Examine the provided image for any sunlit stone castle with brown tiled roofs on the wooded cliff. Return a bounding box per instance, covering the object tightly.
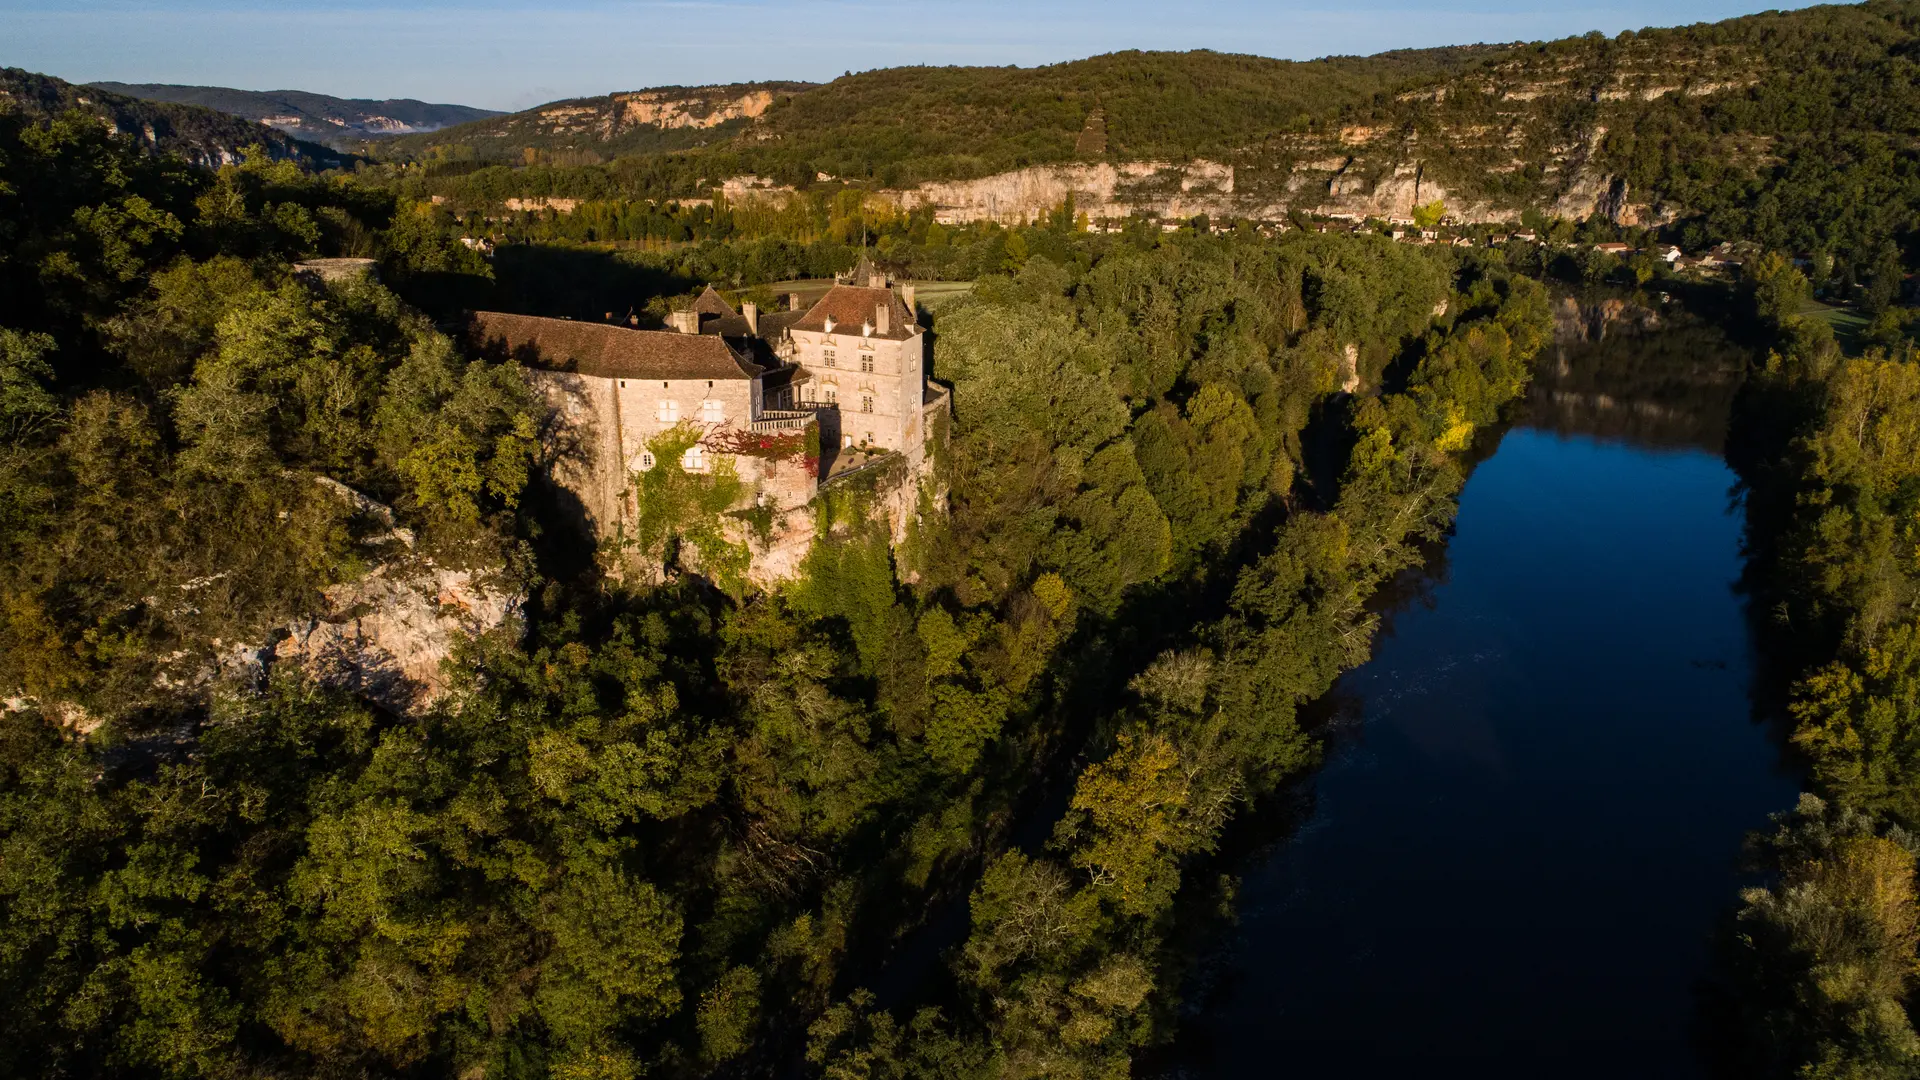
[468,259,948,568]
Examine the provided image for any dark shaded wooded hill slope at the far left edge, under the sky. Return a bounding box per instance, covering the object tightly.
[0,67,353,169]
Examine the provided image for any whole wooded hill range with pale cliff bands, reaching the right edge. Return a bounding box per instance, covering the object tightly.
[376,0,1920,247]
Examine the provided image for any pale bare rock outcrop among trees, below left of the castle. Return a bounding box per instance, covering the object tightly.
[263,567,522,713]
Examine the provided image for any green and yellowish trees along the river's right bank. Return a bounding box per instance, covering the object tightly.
[1715,256,1920,1078]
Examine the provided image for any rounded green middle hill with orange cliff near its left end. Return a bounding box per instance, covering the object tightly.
[380,46,1482,184]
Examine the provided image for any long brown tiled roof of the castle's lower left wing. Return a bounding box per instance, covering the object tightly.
[467,311,760,379]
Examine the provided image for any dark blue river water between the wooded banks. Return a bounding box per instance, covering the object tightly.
[1173,305,1799,1078]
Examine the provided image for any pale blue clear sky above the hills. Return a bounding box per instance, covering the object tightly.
[0,0,1801,110]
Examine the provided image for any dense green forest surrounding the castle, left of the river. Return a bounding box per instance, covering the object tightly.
[0,88,1549,1078]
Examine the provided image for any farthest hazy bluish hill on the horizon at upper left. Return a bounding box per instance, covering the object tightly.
[88,83,503,142]
